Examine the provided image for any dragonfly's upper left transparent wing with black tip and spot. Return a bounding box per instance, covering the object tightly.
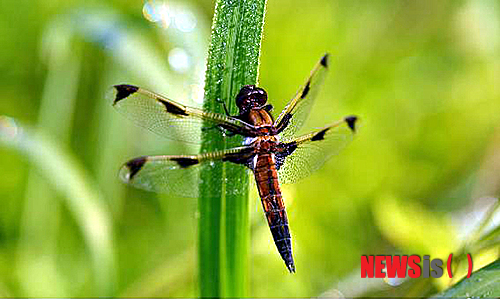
[111,84,254,144]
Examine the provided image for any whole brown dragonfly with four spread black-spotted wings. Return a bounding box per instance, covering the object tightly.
[112,54,358,273]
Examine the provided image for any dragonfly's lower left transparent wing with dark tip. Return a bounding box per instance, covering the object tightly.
[119,146,253,197]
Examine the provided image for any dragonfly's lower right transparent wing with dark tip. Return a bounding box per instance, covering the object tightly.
[275,116,357,184]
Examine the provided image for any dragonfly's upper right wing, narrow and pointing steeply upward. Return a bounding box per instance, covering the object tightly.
[274,54,328,141]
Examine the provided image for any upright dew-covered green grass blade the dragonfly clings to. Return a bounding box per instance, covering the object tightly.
[199,0,266,297]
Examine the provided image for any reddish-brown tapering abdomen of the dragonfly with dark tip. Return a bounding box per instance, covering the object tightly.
[254,154,295,272]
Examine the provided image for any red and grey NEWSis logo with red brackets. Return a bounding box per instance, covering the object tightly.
[361,254,472,278]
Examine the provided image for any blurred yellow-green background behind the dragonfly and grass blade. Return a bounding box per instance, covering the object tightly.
[0,0,500,297]
